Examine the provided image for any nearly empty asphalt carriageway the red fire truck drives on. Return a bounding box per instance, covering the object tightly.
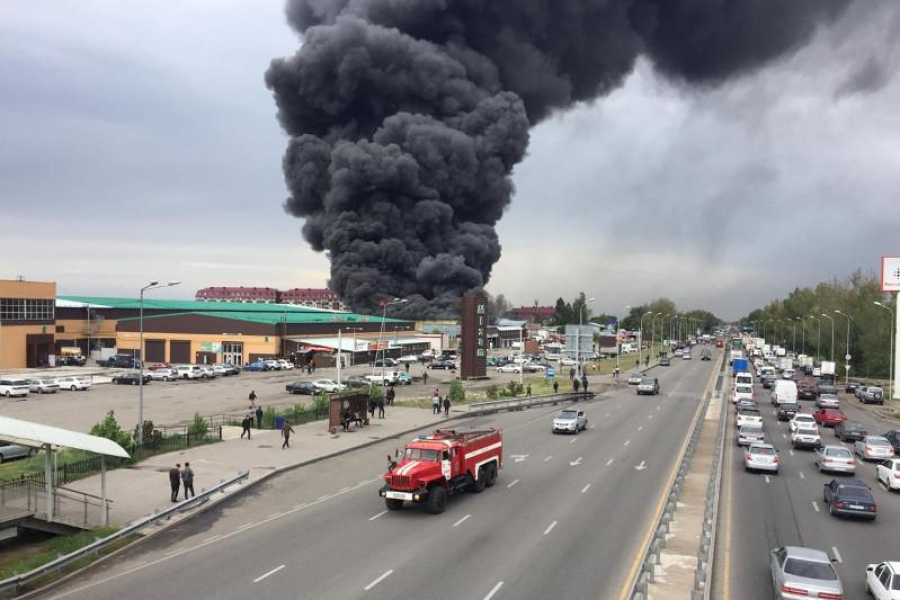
[44,352,715,600]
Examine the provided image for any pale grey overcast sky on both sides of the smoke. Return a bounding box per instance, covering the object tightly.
[0,0,900,319]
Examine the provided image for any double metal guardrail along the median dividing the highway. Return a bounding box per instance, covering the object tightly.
[625,354,728,600]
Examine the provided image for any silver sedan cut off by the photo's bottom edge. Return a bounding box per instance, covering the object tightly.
[771,546,844,600]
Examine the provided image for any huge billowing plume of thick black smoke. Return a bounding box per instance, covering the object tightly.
[266,0,849,317]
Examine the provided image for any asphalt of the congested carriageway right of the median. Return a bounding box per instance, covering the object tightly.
[713,372,900,600]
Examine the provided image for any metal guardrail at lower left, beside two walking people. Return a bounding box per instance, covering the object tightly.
[0,471,250,593]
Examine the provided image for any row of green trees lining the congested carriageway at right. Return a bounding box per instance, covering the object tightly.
[741,270,896,378]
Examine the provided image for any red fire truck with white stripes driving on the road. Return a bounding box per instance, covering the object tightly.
[380,428,503,515]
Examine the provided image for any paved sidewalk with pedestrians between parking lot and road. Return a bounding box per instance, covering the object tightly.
[67,406,445,526]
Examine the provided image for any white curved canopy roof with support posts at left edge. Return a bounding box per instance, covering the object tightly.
[0,417,129,525]
